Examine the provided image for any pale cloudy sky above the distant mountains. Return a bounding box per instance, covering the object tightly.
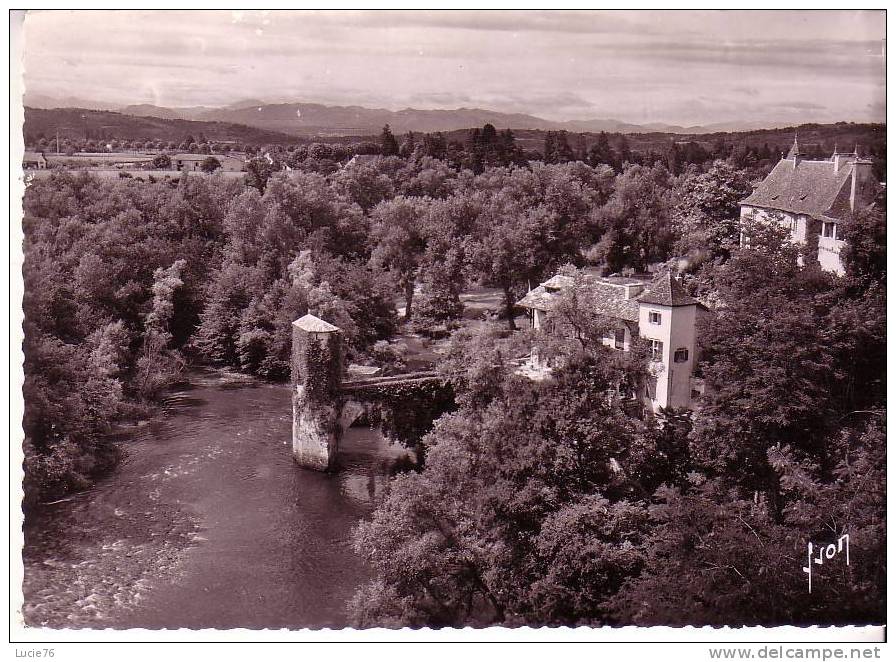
[23,10,886,126]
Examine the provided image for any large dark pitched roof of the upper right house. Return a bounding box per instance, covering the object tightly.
[740,159,855,219]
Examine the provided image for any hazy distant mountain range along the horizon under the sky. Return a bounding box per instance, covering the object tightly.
[19,93,792,138]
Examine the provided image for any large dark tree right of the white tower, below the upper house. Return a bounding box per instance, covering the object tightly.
[691,222,885,517]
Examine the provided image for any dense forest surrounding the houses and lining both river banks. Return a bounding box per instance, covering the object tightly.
[17,125,886,627]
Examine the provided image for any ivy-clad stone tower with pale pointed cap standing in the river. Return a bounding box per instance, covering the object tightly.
[292,315,342,471]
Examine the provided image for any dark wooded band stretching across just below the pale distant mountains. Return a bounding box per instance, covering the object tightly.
[26,116,886,181]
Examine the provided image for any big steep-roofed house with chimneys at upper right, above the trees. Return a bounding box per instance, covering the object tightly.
[740,137,874,275]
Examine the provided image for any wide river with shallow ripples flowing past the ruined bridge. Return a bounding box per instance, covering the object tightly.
[23,371,406,629]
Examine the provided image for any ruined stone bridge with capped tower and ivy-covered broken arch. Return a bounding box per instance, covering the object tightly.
[292,315,453,471]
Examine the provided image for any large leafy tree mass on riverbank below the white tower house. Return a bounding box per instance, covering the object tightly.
[351,350,647,627]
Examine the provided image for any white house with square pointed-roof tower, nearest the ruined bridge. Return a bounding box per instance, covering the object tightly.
[517,270,705,412]
